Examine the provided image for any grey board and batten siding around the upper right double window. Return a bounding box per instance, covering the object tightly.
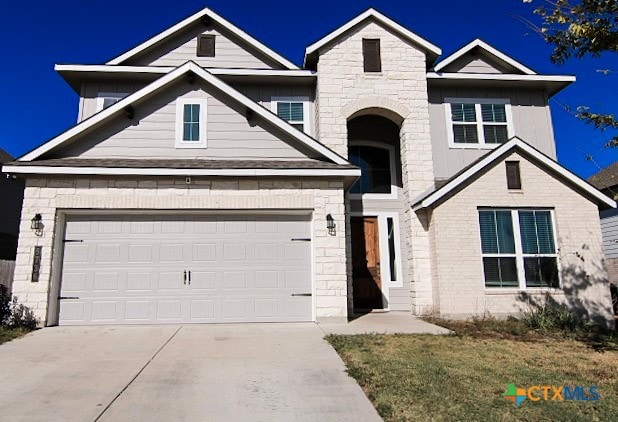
[429,86,556,180]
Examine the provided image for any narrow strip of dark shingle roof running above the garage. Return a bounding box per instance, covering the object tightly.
[7,158,356,170]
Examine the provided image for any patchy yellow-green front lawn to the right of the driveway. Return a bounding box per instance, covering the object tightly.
[327,320,618,421]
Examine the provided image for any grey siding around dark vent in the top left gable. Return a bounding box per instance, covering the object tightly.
[123,23,281,69]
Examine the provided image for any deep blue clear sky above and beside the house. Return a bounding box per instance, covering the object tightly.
[0,0,618,177]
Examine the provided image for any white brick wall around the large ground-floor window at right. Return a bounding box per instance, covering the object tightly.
[431,153,610,326]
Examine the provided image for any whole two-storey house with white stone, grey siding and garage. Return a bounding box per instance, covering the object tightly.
[5,9,616,325]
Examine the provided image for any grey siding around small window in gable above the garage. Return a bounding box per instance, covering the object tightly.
[54,82,315,160]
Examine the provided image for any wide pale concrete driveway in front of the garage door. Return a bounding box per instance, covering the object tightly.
[0,323,380,422]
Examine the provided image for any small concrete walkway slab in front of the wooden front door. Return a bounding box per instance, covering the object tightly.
[319,312,451,334]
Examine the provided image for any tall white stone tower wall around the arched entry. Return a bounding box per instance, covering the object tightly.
[316,22,434,314]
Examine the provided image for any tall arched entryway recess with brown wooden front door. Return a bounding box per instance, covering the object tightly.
[347,112,403,312]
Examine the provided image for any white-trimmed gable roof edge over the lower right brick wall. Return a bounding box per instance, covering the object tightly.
[412,137,616,211]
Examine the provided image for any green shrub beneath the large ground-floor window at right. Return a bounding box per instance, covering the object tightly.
[521,301,584,332]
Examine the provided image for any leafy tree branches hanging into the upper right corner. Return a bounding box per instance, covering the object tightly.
[523,0,618,147]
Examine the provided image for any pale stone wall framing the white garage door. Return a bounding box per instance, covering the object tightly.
[13,178,347,325]
